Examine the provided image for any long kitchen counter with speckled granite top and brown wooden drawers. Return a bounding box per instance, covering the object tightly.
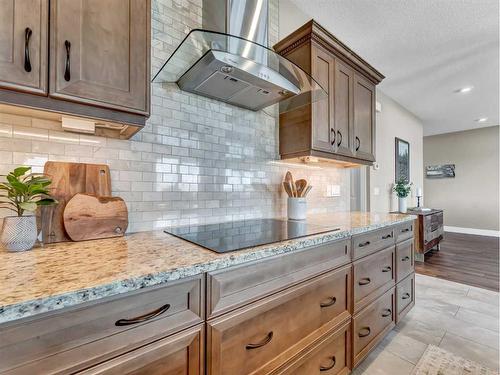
[0,213,415,374]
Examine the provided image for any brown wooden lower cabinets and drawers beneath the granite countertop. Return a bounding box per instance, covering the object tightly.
[0,222,415,375]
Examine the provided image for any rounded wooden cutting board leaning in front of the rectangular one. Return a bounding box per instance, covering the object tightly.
[63,193,128,241]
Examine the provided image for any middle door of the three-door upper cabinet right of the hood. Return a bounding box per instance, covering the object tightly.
[334,59,354,156]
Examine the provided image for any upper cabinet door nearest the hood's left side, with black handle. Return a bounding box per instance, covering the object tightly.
[50,0,151,114]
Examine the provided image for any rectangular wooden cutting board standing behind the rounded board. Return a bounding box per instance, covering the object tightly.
[41,161,111,243]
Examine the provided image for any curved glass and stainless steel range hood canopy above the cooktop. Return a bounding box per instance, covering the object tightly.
[152,29,328,113]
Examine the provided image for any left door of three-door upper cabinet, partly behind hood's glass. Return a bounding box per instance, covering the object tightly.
[311,44,335,153]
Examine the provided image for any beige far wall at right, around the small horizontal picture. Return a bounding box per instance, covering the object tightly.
[424,126,499,230]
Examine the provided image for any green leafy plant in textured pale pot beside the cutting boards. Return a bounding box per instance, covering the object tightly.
[0,167,57,251]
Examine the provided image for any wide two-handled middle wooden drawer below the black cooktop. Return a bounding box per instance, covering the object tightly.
[207,266,351,375]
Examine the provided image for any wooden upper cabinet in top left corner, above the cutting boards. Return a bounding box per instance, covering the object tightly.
[0,0,151,138]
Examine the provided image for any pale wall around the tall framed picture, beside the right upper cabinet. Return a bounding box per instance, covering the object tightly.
[370,90,423,212]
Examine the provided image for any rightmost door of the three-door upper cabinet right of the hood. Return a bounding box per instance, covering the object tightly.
[353,74,375,161]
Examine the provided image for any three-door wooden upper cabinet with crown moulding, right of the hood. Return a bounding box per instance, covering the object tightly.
[274,21,384,164]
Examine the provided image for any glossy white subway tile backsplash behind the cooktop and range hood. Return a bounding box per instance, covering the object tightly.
[0,0,349,232]
